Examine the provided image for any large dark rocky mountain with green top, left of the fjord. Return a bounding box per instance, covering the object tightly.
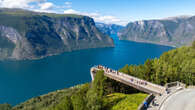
[0,9,114,60]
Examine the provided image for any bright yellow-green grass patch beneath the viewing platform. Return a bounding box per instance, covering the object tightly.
[103,93,147,110]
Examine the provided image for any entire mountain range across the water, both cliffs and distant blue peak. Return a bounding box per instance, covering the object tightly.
[0,8,195,60]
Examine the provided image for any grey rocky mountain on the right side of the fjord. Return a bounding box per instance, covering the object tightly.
[118,16,195,47]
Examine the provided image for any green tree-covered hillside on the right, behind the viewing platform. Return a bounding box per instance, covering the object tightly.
[120,42,195,85]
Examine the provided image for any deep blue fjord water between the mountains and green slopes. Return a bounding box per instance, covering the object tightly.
[0,35,172,105]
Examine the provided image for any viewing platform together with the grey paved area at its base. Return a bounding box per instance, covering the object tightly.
[90,65,195,110]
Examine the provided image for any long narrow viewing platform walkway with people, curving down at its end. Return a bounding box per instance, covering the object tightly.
[90,65,166,95]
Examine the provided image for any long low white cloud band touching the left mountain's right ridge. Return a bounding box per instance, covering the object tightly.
[64,9,128,25]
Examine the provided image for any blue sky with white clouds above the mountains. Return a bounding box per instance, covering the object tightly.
[0,0,195,25]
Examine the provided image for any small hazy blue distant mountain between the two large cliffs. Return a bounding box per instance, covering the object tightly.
[96,22,124,35]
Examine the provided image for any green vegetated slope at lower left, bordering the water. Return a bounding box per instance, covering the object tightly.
[11,85,83,110]
